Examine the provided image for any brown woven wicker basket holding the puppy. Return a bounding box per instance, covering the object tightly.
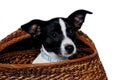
[0,29,107,80]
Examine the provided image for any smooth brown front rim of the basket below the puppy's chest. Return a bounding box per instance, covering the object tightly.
[0,52,97,68]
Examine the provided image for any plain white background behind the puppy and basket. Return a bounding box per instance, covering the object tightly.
[0,0,120,80]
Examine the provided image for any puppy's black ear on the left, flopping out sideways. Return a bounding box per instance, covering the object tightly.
[21,20,45,37]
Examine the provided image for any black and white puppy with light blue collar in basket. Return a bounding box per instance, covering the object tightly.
[21,10,92,63]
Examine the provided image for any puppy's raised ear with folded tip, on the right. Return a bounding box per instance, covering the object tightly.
[68,10,92,29]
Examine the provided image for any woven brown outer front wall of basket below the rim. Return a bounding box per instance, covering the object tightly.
[0,56,106,80]
